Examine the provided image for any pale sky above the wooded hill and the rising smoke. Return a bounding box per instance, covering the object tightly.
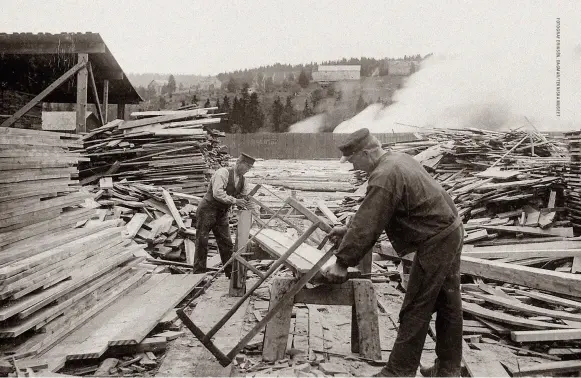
[0,0,581,75]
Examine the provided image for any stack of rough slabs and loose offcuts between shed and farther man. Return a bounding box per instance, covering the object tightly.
[73,108,235,262]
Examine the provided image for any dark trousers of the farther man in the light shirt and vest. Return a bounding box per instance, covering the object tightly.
[194,199,233,278]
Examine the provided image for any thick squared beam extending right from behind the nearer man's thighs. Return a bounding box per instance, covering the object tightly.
[460,256,581,298]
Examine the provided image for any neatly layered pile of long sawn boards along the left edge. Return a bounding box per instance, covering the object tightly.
[0,128,200,371]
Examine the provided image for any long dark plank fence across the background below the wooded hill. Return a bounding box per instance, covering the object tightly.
[221,133,416,160]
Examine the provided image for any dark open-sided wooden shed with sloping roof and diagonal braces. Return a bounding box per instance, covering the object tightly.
[0,33,142,133]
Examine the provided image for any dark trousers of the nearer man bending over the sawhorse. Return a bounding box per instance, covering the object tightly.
[381,226,464,377]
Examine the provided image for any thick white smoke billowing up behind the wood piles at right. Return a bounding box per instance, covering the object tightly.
[334,20,581,133]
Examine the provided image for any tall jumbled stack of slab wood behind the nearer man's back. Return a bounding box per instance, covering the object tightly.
[336,129,573,243]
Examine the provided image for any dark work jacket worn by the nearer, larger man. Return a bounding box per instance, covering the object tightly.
[336,152,462,266]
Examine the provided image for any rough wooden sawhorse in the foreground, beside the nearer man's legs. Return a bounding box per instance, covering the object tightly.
[262,277,381,361]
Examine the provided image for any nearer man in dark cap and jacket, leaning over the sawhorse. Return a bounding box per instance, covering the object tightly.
[322,129,464,377]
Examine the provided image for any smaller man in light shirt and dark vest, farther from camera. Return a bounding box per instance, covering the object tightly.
[194,154,256,278]
